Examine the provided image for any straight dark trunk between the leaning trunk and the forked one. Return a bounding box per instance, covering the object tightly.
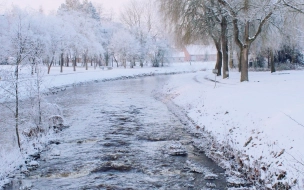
[221,17,229,79]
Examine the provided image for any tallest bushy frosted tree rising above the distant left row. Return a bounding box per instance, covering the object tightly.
[58,1,104,70]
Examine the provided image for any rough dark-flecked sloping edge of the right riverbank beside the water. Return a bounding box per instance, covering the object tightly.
[154,91,296,190]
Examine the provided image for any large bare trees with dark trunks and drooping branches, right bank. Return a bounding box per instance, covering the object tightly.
[159,0,303,82]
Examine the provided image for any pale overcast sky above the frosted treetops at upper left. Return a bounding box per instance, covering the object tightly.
[0,0,129,14]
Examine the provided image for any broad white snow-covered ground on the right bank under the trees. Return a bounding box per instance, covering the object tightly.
[163,71,304,189]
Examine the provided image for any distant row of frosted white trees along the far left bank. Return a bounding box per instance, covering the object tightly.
[0,0,169,73]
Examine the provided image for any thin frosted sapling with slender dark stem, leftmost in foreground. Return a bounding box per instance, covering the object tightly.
[0,7,39,149]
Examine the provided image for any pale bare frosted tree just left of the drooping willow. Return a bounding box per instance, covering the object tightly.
[120,0,171,67]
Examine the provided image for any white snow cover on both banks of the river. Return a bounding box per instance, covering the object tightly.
[0,63,304,189]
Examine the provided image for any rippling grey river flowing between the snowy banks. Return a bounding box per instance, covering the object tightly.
[6,76,226,190]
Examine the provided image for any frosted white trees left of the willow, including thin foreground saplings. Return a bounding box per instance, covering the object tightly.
[0,0,170,149]
